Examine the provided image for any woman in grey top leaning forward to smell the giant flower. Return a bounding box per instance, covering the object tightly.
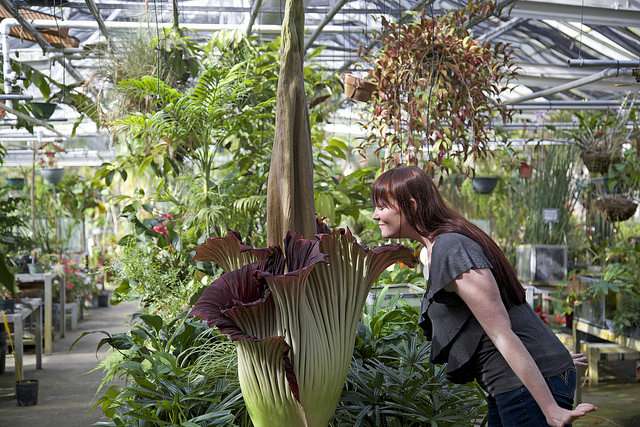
[372,167,596,427]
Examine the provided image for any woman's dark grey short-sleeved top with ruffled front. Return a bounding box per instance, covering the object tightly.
[420,233,573,395]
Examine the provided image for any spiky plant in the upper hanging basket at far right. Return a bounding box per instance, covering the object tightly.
[564,102,635,175]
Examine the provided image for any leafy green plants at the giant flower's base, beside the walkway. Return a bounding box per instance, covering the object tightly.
[79,313,248,427]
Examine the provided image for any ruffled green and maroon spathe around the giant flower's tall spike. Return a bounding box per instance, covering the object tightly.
[192,230,414,427]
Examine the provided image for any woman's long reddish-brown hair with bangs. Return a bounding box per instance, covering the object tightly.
[371,167,525,308]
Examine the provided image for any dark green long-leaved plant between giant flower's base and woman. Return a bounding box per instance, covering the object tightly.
[333,335,486,427]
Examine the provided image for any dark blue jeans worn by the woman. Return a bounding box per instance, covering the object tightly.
[487,368,576,427]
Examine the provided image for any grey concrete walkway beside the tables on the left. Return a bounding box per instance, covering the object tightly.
[0,303,138,427]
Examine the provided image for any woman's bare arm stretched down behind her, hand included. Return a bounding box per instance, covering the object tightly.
[448,269,596,427]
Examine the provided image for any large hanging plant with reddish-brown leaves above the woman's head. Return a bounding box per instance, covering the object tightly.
[361,1,515,171]
